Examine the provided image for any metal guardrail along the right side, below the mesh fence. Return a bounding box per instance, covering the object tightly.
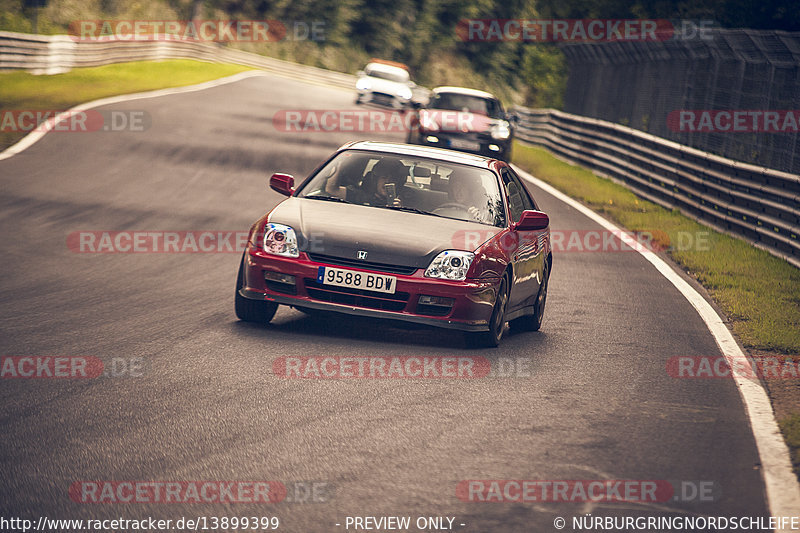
[516,108,800,268]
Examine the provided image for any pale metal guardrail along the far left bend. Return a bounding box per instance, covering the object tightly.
[0,31,356,89]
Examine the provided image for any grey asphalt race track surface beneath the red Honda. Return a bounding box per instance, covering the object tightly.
[0,71,767,532]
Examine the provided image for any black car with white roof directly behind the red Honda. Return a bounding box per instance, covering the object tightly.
[407,87,517,161]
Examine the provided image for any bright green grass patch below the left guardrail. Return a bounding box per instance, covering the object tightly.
[0,59,251,150]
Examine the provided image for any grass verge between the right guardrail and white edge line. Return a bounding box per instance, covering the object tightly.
[514,143,800,354]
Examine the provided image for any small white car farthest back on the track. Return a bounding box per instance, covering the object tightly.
[356,59,416,109]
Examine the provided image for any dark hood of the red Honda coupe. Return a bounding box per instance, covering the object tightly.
[269,197,501,268]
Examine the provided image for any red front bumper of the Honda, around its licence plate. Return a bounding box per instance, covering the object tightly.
[239,245,500,331]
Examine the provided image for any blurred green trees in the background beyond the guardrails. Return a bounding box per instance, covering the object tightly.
[0,0,800,108]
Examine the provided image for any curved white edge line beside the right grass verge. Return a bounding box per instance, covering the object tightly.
[514,165,800,532]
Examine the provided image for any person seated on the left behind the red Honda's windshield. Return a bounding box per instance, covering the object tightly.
[325,158,408,207]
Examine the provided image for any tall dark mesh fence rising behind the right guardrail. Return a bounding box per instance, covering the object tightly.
[559,28,800,174]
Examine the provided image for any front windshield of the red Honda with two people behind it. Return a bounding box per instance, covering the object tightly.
[297,150,505,227]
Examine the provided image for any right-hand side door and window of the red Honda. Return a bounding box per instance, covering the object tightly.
[500,167,545,310]
